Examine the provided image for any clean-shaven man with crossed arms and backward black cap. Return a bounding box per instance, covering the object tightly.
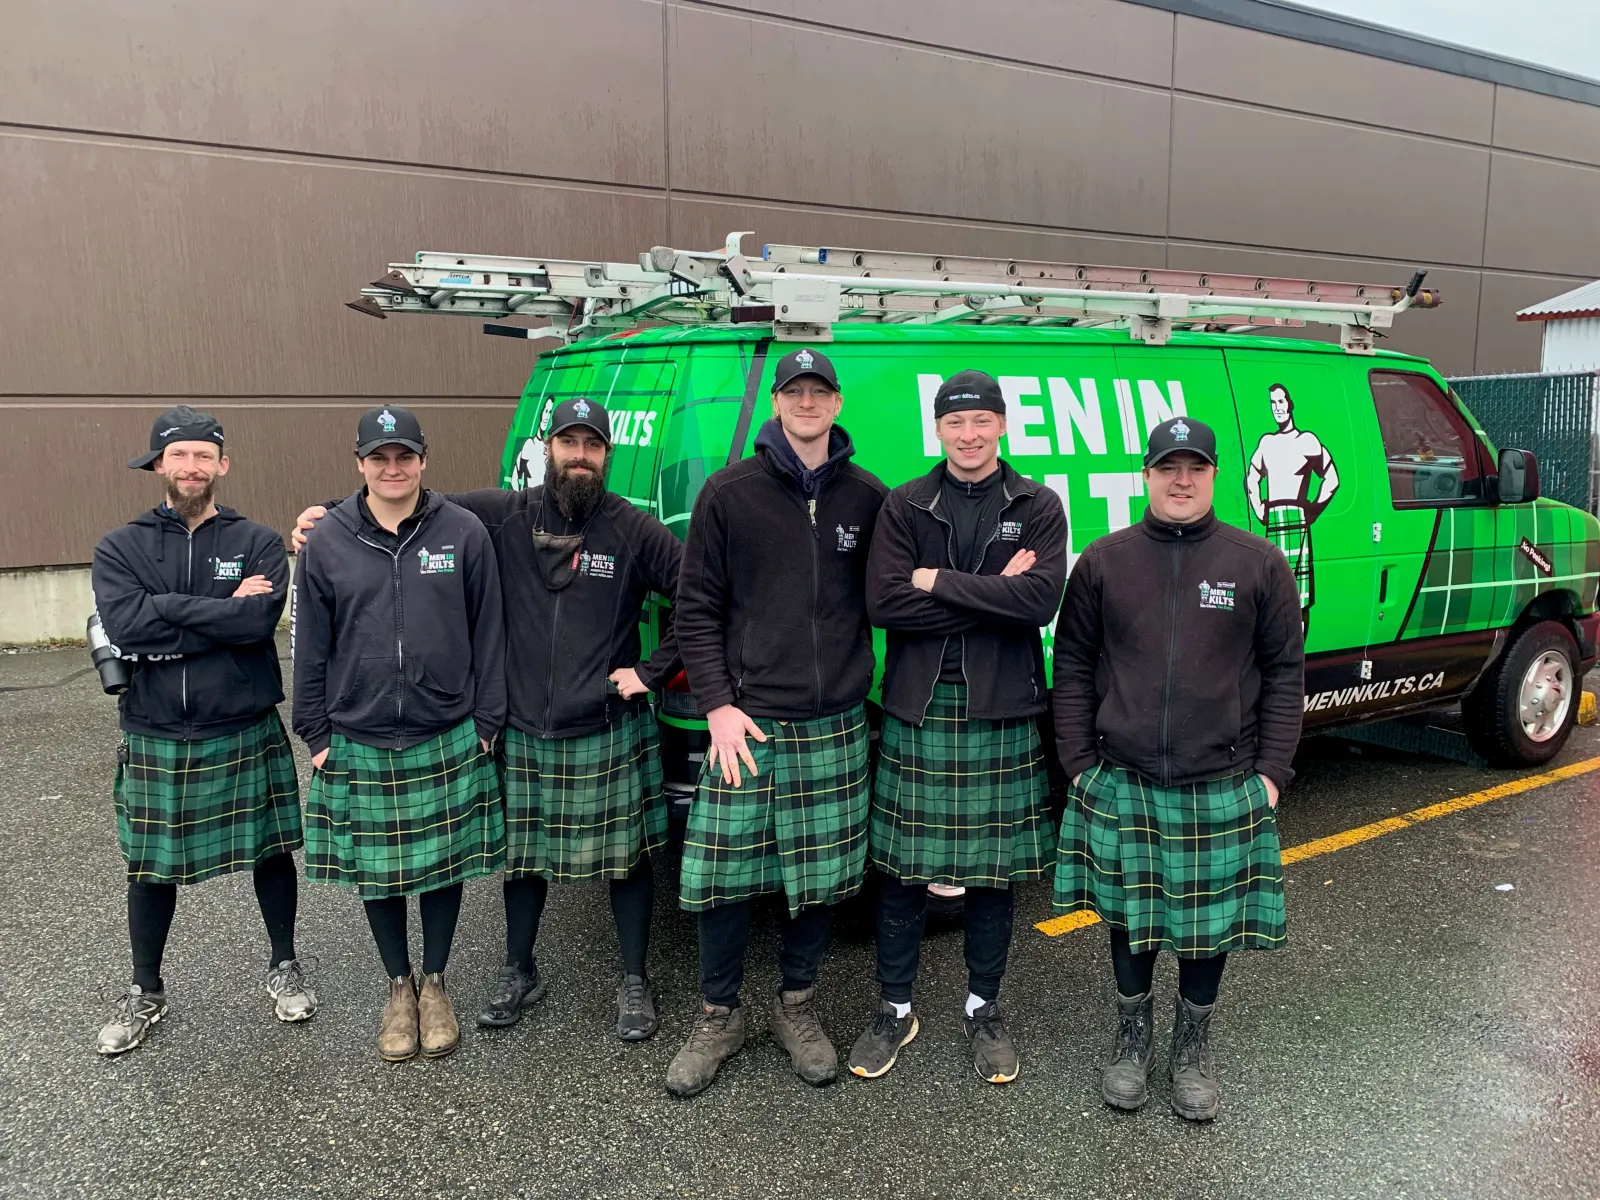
[850,371,1067,1083]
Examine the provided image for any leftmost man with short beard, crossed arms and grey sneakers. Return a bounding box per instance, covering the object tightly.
[93,405,317,1054]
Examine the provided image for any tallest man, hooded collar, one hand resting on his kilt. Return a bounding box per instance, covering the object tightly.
[667,349,888,1096]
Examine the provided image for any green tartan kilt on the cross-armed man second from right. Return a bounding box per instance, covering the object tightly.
[869,683,1056,888]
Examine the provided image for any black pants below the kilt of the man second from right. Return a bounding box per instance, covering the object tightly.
[878,874,1016,1005]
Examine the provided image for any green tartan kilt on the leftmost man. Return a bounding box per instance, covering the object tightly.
[112,709,301,883]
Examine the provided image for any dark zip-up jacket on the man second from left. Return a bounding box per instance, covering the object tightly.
[291,488,506,754]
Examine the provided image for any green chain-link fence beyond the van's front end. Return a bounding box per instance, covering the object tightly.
[1450,371,1600,512]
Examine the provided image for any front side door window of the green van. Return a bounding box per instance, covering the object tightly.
[1371,371,1483,509]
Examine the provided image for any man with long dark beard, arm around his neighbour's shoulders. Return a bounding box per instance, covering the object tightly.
[296,398,683,1042]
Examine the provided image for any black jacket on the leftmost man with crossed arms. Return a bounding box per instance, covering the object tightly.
[90,504,290,741]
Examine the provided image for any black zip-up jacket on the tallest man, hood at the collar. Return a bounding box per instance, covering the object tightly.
[675,421,888,720]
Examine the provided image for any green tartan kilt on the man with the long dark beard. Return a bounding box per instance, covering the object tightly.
[501,706,667,883]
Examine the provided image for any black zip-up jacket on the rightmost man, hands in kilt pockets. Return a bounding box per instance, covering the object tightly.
[1054,510,1306,789]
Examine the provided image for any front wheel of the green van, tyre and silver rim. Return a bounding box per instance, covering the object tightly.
[1461,621,1579,766]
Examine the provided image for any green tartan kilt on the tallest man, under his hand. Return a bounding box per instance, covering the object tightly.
[678,704,869,914]
